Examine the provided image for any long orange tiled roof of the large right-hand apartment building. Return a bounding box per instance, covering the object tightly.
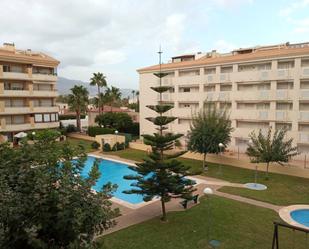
[137,47,309,73]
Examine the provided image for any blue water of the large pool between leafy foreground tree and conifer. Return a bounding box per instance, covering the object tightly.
[82,156,143,204]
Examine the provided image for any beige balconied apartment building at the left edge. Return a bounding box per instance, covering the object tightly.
[0,43,59,141]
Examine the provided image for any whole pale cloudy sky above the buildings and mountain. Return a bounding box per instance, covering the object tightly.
[0,0,309,89]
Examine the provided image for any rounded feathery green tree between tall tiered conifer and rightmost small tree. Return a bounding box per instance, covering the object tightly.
[188,103,233,170]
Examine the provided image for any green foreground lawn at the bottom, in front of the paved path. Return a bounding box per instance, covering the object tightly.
[99,196,309,249]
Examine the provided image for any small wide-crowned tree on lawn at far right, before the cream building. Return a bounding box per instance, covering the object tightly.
[246,127,298,178]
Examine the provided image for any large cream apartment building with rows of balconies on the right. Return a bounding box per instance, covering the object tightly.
[138,43,309,153]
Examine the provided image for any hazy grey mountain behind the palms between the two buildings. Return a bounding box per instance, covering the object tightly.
[57,77,136,98]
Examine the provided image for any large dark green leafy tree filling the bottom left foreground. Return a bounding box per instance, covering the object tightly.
[0,131,118,249]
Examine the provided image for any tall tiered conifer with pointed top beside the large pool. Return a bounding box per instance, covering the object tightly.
[125,52,194,221]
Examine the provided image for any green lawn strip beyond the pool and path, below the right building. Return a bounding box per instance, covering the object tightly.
[102,149,309,205]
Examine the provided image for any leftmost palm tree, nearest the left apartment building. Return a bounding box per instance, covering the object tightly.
[68,85,89,131]
